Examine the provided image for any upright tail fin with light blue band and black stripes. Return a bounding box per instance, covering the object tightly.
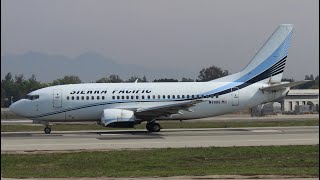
[238,24,294,83]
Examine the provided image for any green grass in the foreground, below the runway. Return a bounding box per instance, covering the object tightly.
[1,145,319,178]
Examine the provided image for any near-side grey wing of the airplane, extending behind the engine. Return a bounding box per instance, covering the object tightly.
[135,99,203,119]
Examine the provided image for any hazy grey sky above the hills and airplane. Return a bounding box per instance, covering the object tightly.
[1,0,319,79]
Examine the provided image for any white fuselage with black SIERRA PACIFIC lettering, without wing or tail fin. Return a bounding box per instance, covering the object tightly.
[9,82,286,121]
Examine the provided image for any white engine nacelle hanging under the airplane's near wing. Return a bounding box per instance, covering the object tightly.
[101,109,136,128]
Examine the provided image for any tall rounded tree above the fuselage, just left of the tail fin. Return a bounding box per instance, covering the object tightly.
[197,65,229,82]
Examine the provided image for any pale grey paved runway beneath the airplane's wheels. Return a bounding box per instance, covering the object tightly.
[1,126,319,153]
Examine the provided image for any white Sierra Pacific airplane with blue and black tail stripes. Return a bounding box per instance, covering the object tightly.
[9,24,304,134]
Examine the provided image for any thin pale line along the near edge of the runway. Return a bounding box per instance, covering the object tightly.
[2,138,318,147]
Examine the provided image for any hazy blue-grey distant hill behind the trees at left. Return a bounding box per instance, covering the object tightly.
[1,51,200,82]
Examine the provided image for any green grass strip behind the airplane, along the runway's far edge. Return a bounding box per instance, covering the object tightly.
[1,119,319,132]
